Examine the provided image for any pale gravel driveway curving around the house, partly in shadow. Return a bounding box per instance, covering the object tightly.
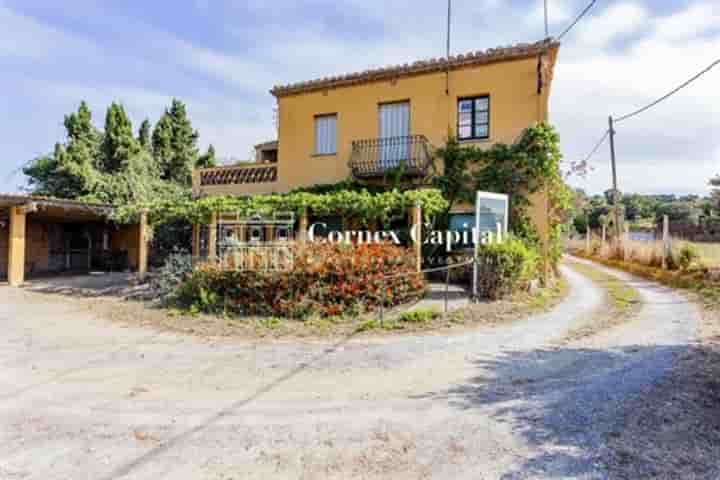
[0,260,699,480]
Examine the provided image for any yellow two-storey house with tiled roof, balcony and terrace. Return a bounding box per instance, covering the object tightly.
[193,40,560,244]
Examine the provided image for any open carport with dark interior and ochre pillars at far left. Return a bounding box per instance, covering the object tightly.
[0,194,148,286]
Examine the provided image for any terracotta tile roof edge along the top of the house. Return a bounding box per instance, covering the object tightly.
[270,39,560,97]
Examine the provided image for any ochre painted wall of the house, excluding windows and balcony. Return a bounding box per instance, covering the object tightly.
[195,50,557,248]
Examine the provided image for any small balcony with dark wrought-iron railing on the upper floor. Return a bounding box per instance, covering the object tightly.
[349,135,432,178]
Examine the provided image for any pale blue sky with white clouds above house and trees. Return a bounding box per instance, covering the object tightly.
[0,0,720,194]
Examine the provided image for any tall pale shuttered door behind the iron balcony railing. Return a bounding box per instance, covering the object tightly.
[378,102,410,170]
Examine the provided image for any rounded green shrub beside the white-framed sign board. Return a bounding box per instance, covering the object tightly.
[478,238,540,300]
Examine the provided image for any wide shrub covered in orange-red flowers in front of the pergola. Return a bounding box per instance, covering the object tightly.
[179,243,426,318]
